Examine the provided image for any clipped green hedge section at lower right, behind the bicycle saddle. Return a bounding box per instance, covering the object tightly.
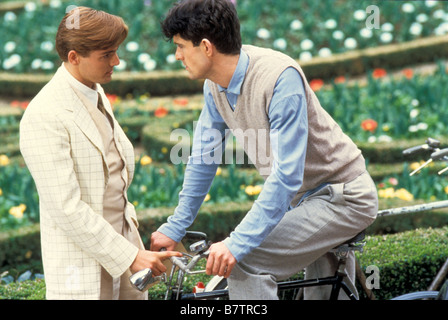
[358,226,448,300]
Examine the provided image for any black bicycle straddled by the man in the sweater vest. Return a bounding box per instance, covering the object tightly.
[129,231,365,300]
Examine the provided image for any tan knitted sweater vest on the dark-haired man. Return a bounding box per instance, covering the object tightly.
[207,45,366,203]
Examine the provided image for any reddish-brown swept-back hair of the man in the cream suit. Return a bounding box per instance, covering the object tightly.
[56,7,129,62]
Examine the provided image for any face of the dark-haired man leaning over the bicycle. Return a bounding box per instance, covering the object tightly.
[173,35,211,79]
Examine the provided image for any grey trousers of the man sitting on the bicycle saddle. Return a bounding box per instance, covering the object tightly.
[228,172,378,300]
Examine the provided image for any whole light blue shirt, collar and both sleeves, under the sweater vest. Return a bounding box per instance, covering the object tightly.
[159,51,308,261]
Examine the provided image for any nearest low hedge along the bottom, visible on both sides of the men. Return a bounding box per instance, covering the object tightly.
[0,227,448,300]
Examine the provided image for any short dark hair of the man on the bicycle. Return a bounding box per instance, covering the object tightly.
[161,0,241,54]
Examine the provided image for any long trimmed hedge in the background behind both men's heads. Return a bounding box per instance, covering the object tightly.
[0,36,448,98]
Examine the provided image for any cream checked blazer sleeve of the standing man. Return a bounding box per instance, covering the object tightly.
[20,106,138,277]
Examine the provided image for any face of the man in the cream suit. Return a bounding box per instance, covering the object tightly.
[71,48,120,88]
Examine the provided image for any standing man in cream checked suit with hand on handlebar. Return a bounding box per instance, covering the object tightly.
[20,7,180,299]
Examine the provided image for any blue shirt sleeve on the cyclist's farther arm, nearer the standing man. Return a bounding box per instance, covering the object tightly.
[158,81,230,242]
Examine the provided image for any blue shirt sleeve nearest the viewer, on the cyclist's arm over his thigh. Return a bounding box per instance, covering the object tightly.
[224,68,308,261]
